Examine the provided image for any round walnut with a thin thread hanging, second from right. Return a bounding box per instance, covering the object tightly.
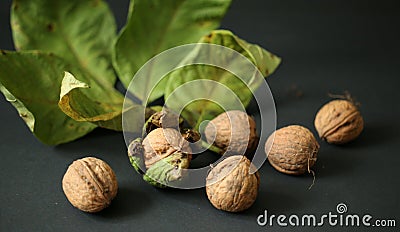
[265,125,319,175]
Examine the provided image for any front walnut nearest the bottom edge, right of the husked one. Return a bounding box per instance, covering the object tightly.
[206,155,260,212]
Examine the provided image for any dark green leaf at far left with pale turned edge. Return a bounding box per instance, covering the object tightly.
[0,51,96,145]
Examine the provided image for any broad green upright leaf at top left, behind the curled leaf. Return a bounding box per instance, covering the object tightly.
[11,0,116,87]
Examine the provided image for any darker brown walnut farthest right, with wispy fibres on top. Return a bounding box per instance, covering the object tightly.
[314,100,364,144]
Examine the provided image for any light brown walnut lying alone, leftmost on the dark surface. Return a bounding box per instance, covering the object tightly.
[62,157,118,213]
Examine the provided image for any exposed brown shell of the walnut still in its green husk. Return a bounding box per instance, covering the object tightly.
[142,128,192,168]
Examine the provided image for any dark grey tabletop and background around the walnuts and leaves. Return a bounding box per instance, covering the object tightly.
[0,0,400,231]
